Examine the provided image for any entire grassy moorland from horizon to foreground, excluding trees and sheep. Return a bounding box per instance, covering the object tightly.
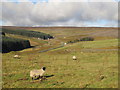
[2,27,118,88]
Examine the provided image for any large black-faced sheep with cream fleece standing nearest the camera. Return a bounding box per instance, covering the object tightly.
[30,67,46,80]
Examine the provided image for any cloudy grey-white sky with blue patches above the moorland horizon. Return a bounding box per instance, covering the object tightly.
[0,0,119,27]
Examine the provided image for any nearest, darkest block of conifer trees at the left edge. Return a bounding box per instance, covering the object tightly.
[0,36,31,53]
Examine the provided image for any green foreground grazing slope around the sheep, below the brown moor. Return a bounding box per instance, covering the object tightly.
[3,39,118,88]
